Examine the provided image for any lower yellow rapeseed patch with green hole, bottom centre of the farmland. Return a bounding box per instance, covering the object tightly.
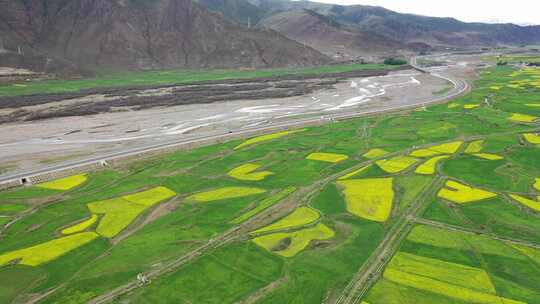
[253,224,335,258]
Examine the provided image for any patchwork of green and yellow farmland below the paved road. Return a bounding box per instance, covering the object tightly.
[0,61,540,304]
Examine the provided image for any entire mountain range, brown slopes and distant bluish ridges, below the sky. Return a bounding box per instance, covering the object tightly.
[0,0,540,72]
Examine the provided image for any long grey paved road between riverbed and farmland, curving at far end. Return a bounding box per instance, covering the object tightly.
[0,58,469,184]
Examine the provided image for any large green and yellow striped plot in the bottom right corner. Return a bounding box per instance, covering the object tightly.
[366,226,540,304]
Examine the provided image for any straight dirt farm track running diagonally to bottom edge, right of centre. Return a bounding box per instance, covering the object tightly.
[334,177,445,304]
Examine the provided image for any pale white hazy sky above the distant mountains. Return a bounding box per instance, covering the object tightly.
[313,0,540,24]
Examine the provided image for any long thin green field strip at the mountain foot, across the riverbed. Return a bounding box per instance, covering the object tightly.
[0,64,396,97]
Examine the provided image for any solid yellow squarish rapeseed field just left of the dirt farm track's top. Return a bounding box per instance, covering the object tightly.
[337,178,394,222]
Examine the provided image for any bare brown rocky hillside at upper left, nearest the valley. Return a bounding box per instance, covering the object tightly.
[0,0,329,70]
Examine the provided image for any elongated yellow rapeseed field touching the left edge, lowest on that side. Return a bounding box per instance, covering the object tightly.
[0,232,98,266]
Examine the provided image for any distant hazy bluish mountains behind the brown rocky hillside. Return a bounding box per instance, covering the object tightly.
[199,0,540,53]
